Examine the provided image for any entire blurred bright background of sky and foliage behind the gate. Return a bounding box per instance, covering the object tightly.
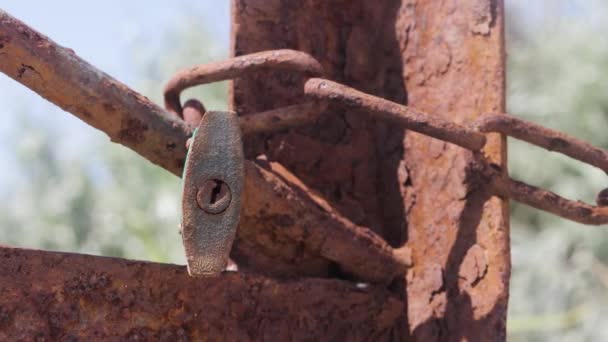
[0,0,608,341]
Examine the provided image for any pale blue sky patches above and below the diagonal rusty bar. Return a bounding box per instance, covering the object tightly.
[0,0,230,187]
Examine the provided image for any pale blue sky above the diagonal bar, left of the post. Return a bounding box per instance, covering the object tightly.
[0,0,230,83]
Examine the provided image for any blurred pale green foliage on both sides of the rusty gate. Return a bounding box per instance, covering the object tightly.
[0,0,608,341]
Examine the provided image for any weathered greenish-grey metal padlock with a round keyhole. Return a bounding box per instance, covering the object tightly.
[181,111,244,277]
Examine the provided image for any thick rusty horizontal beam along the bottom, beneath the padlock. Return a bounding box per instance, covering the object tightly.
[0,247,403,341]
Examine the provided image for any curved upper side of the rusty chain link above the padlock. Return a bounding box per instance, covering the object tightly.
[164,50,323,117]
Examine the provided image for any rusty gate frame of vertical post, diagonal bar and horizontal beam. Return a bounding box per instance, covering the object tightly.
[0,0,510,341]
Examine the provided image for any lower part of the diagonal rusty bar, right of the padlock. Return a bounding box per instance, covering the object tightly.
[238,160,411,283]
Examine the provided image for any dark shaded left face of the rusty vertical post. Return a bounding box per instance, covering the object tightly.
[232,0,406,256]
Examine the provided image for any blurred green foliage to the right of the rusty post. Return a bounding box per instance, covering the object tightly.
[507,0,608,341]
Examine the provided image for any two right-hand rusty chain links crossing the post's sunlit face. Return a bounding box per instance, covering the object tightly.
[304,78,608,225]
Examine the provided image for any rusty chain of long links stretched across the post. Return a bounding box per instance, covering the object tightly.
[165,50,608,225]
